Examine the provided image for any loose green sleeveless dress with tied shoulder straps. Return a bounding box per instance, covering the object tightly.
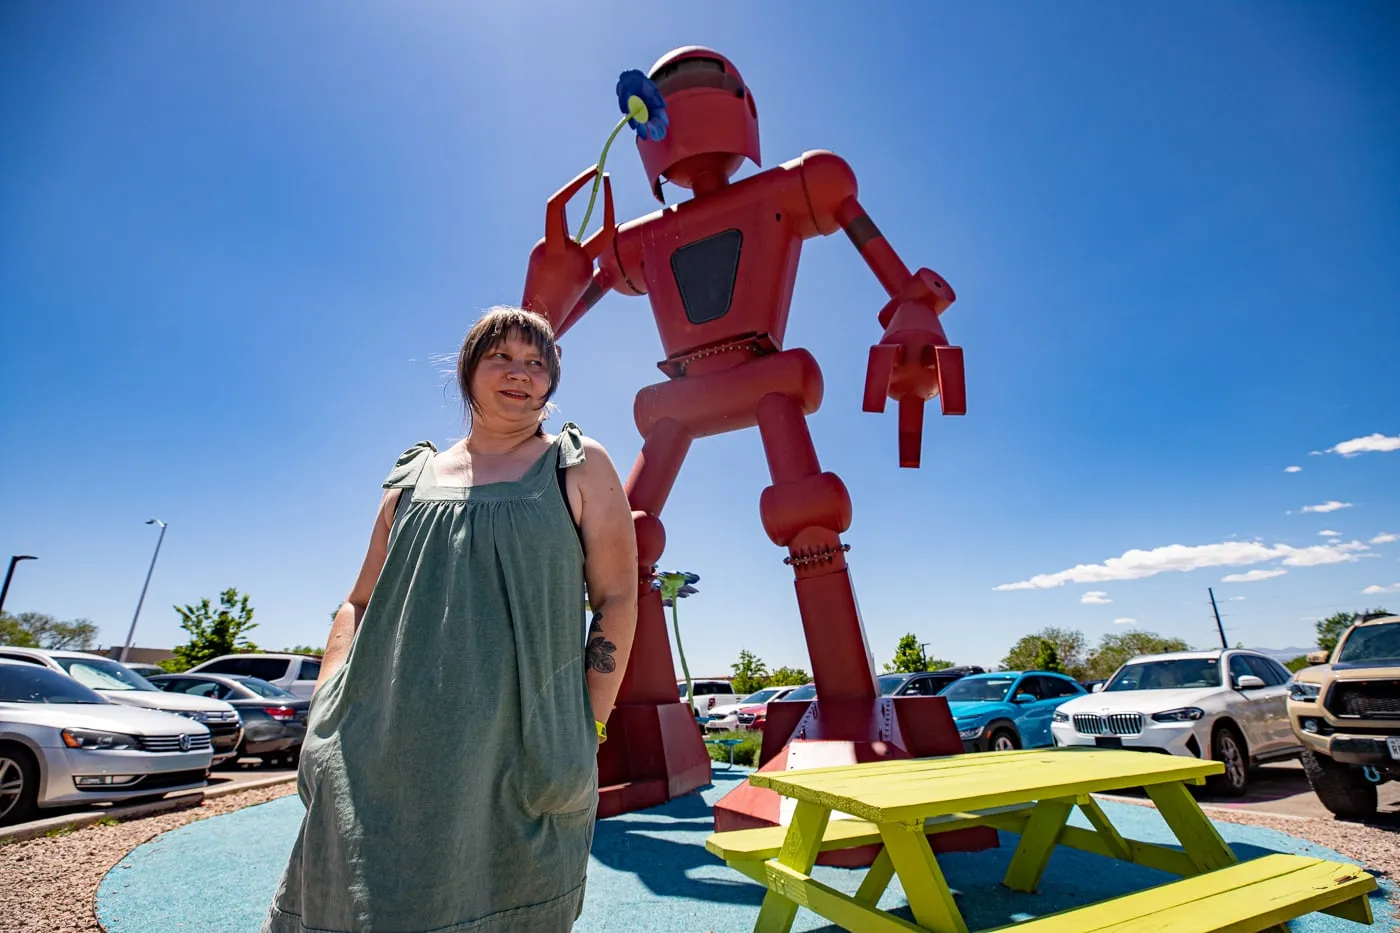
[263,423,598,933]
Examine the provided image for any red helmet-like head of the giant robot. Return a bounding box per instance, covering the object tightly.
[637,45,762,203]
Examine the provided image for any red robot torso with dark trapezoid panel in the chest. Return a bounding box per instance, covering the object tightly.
[643,207,802,352]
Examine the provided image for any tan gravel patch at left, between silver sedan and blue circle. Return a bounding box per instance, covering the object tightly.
[0,783,297,933]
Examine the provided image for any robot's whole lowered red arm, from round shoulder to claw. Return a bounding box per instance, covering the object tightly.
[802,153,967,467]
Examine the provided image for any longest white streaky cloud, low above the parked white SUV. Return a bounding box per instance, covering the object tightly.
[994,541,1371,591]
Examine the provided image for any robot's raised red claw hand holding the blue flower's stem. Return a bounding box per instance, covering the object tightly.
[521,165,617,336]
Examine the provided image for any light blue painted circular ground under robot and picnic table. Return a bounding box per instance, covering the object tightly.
[97,769,1396,933]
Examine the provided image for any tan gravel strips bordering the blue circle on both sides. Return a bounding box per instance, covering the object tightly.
[0,783,1400,933]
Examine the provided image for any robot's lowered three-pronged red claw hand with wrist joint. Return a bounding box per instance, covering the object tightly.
[862,269,967,467]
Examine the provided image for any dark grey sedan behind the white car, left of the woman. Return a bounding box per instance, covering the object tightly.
[147,674,311,765]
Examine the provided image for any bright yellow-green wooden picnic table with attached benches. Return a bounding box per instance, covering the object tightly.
[706,749,1376,933]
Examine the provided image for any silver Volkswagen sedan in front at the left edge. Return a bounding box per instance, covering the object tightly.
[0,661,213,825]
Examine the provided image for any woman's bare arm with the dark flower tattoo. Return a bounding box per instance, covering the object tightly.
[566,437,637,723]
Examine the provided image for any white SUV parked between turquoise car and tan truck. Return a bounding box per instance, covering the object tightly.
[1050,650,1302,797]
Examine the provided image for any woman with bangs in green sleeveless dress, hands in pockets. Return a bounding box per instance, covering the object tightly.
[263,308,637,933]
